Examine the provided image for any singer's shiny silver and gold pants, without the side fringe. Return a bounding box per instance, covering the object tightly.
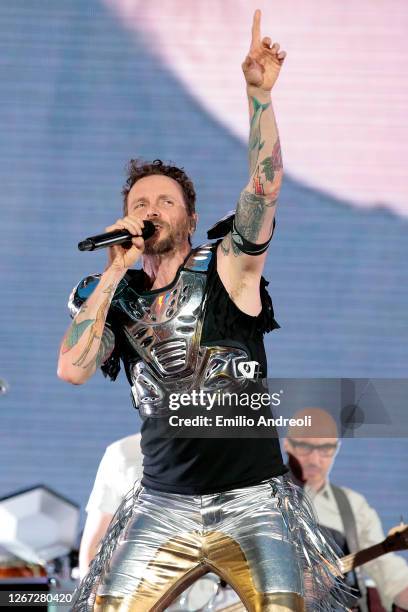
[94,483,304,612]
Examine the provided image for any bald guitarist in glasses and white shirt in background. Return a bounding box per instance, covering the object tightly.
[284,408,408,610]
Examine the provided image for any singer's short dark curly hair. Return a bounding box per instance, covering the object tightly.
[122,159,196,217]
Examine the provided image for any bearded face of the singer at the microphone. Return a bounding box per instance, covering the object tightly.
[127,174,195,255]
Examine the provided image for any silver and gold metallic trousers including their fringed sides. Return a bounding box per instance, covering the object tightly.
[73,477,347,612]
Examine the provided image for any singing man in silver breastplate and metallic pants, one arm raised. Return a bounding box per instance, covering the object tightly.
[58,10,350,612]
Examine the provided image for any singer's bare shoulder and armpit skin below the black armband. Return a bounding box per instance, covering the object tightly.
[217,239,262,317]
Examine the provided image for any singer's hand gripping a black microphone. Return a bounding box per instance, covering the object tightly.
[78,216,155,270]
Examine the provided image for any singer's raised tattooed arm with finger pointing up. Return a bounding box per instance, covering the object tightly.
[219,10,286,277]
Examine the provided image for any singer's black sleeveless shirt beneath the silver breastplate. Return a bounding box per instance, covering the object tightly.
[102,242,287,495]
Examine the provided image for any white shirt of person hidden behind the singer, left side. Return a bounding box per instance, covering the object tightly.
[85,434,143,514]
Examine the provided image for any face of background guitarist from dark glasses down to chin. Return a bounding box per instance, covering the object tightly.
[285,437,338,487]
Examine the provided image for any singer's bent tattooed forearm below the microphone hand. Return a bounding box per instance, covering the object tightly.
[58,268,125,385]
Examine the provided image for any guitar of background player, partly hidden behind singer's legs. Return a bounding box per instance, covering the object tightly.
[217,523,408,612]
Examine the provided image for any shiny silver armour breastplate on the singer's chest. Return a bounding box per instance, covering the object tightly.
[116,245,249,416]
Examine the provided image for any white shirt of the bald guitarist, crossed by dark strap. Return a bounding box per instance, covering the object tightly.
[305,483,408,610]
